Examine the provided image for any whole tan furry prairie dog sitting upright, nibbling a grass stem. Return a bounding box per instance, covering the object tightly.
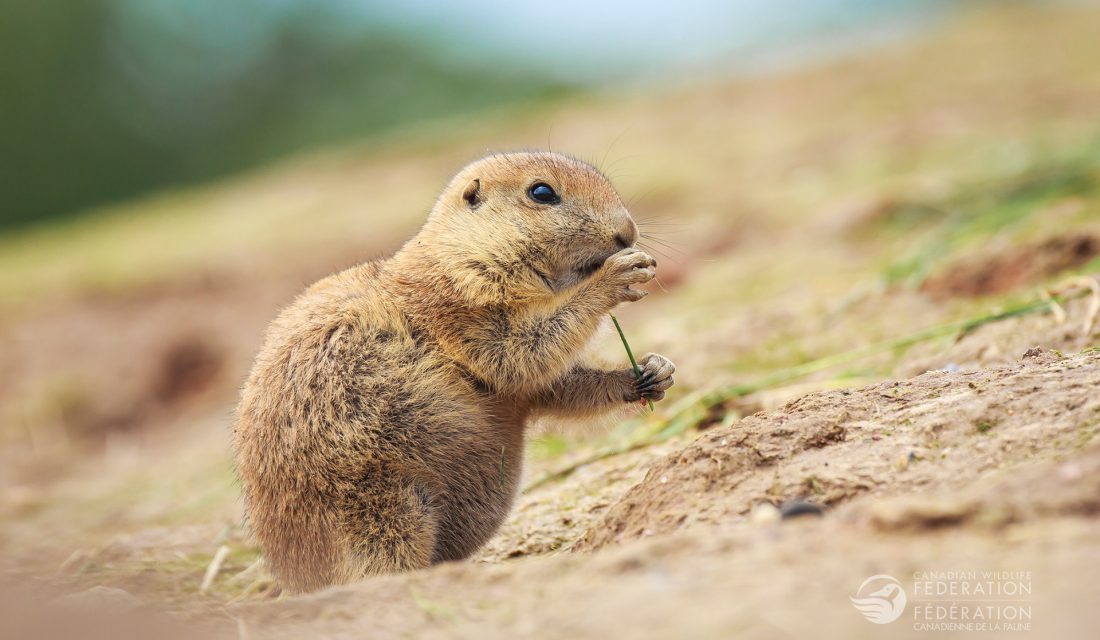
[234,153,674,592]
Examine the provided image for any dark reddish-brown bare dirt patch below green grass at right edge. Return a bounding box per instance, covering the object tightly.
[921,233,1100,298]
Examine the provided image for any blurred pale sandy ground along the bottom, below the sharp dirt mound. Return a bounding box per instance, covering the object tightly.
[228,442,1100,638]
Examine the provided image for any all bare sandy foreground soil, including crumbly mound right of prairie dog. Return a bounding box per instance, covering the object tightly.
[10,350,1100,638]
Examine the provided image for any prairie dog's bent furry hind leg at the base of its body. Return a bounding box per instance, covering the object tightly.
[342,477,439,582]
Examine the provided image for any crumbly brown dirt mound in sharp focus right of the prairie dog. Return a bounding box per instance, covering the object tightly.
[574,351,1100,550]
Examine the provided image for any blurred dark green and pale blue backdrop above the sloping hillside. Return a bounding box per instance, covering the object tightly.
[0,0,959,232]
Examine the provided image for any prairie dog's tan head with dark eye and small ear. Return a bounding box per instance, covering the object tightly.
[406,152,638,304]
